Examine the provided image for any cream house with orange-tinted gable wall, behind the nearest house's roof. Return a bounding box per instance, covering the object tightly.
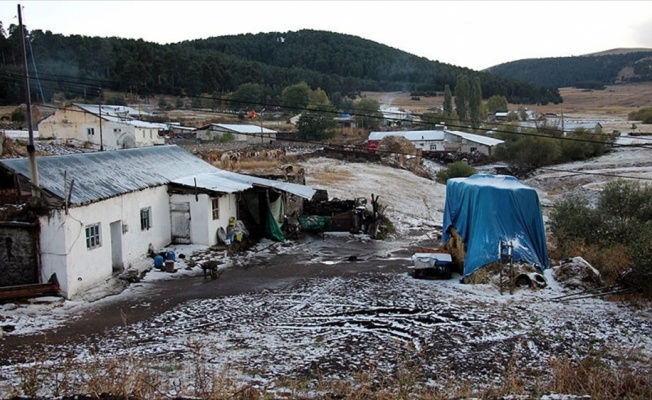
[38,104,167,150]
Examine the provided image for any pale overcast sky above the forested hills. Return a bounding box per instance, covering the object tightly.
[0,0,652,70]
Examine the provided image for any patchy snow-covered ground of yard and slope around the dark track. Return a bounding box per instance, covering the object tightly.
[0,142,652,397]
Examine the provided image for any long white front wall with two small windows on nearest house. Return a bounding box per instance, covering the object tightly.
[40,186,171,298]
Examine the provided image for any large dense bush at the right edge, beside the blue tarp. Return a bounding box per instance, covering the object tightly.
[548,179,652,294]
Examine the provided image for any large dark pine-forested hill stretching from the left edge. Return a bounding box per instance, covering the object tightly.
[0,25,562,104]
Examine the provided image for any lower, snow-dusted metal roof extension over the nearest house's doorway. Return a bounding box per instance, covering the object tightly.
[172,170,316,200]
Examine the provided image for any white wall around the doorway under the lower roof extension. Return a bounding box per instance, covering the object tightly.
[170,194,237,246]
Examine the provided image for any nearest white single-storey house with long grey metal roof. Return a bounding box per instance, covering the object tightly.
[0,145,315,298]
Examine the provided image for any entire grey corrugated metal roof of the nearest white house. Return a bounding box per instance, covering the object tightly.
[0,146,315,205]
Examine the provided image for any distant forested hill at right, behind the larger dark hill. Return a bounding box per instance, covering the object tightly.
[486,49,652,89]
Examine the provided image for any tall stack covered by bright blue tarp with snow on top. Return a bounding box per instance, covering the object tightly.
[442,174,549,277]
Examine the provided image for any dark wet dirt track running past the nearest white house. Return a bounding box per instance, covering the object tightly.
[0,231,433,365]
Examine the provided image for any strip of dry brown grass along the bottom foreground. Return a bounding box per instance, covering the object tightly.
[6,340,652,400]
